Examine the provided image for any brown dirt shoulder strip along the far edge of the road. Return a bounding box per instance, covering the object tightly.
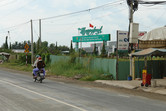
[0,67,166,101]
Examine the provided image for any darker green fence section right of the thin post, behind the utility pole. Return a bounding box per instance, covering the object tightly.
[118,60,166,80]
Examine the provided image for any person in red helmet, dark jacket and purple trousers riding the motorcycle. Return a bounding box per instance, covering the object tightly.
[33,57,45,78]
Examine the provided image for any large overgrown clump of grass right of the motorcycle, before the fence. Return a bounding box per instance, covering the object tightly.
[49,61,113,81]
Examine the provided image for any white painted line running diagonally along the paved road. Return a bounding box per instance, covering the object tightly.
[0,80,87,111]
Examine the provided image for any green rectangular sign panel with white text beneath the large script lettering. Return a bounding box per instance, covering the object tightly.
[73,34,110,42]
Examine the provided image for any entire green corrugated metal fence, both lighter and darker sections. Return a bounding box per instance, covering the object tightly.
[50,55,166,80]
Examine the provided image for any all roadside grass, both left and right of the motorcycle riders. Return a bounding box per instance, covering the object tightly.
[0,61,113,81]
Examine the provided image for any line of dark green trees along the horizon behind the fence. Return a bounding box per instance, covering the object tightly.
[0,36,107,57]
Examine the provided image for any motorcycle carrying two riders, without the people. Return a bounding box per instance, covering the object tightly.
[33,69,45,83]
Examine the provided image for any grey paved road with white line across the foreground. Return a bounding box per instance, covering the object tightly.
[0,70,166,111]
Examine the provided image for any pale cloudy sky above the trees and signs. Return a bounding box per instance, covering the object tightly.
[0,0,166,47]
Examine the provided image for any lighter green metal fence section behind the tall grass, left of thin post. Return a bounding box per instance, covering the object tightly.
[50,55,116,79]
